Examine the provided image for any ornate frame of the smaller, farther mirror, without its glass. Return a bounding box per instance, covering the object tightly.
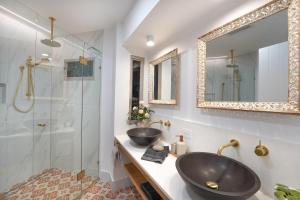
[148,49,180,105]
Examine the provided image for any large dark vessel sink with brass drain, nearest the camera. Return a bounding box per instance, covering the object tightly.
[176,152,261,200]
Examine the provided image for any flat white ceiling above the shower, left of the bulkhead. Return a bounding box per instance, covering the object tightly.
[17,0,137,34]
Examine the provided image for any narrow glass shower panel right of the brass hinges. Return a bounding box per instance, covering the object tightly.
[81,44,101,191]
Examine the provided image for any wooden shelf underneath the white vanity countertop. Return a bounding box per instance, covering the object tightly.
[124,163,148,200]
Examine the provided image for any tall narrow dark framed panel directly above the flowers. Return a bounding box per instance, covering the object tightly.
[129,56,144,118]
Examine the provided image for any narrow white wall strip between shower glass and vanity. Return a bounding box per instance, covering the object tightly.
[100,28,116,180]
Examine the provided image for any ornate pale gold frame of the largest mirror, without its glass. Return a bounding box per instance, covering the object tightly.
[197,0,300,114]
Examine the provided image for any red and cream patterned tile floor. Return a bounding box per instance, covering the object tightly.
[0,168,141,200]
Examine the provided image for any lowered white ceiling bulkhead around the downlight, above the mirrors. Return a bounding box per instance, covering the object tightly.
[124,0,269,57]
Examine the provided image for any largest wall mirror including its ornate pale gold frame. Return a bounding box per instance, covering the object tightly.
[197,0,299,113]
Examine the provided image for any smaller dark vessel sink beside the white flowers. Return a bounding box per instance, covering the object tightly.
[127,128,161,146]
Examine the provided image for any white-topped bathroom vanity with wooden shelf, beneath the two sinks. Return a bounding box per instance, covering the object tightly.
[115,134,271,200]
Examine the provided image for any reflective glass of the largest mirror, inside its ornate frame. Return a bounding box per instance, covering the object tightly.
[205,10,288,102]
